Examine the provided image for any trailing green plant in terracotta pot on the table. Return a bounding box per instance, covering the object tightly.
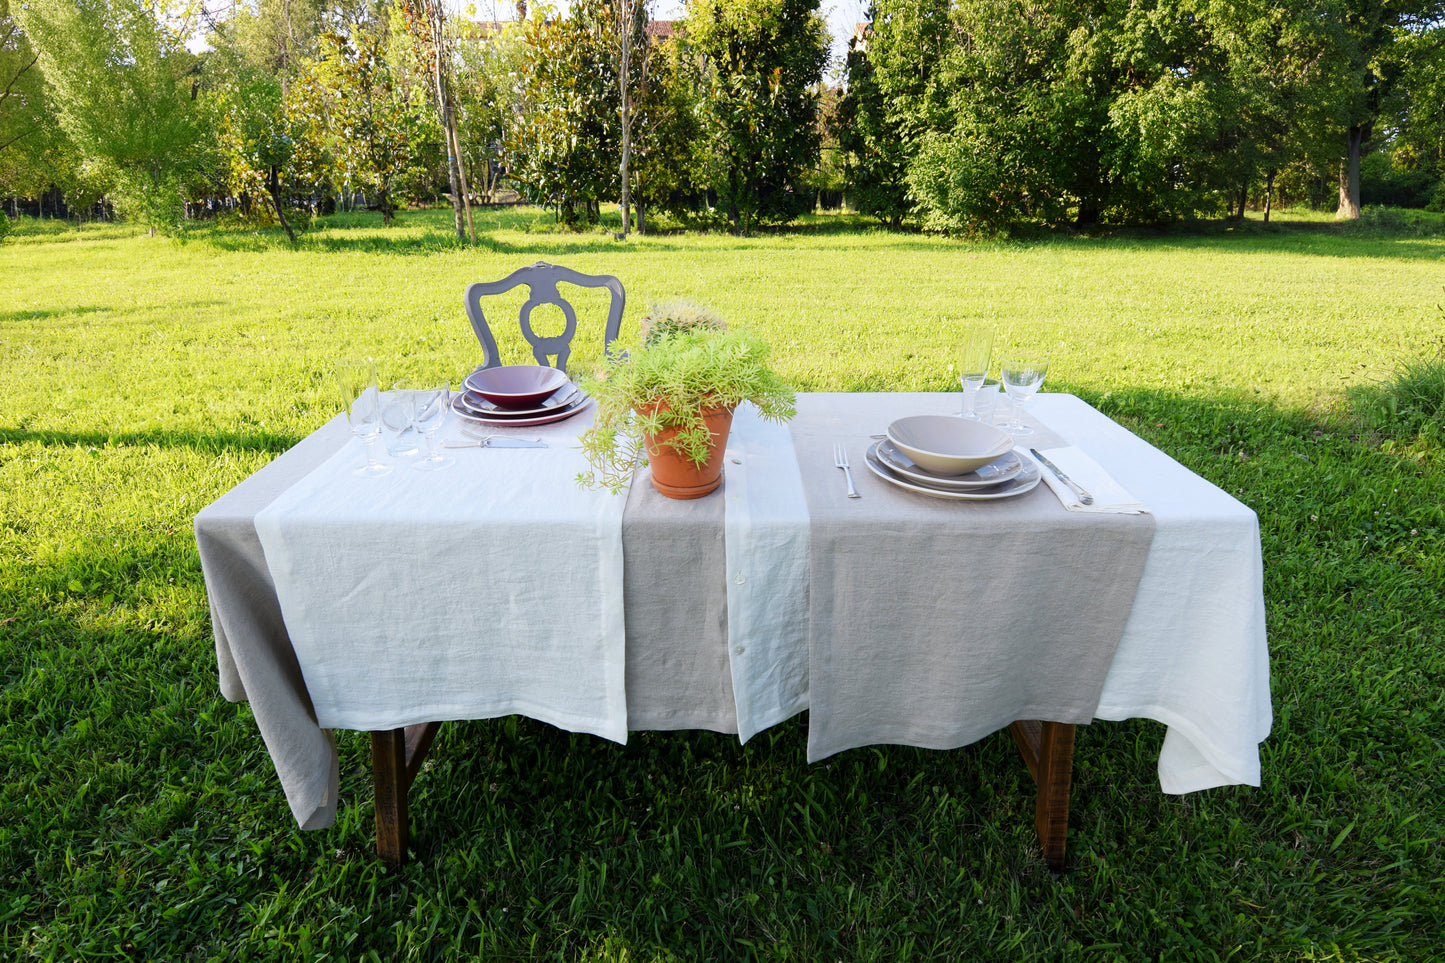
[578,302,795,499]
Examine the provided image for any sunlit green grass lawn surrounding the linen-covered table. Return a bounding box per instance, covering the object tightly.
[0,208,1445,962]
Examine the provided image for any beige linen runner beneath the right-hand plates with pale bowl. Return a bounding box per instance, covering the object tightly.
[792,395,1155,761]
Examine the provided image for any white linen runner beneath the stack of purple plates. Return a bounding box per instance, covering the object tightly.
[256,401,627,743]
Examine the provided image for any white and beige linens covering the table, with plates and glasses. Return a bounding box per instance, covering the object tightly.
[197,333,1270,856]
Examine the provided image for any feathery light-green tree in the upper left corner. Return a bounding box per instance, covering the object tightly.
[20,0,207,233]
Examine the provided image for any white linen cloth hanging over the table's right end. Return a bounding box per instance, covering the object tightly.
[1032,395,1273,792]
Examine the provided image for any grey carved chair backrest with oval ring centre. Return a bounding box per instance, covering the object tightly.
[465,260,627,370]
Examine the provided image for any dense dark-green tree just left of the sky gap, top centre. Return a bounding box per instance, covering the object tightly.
[682,0,828,234]
